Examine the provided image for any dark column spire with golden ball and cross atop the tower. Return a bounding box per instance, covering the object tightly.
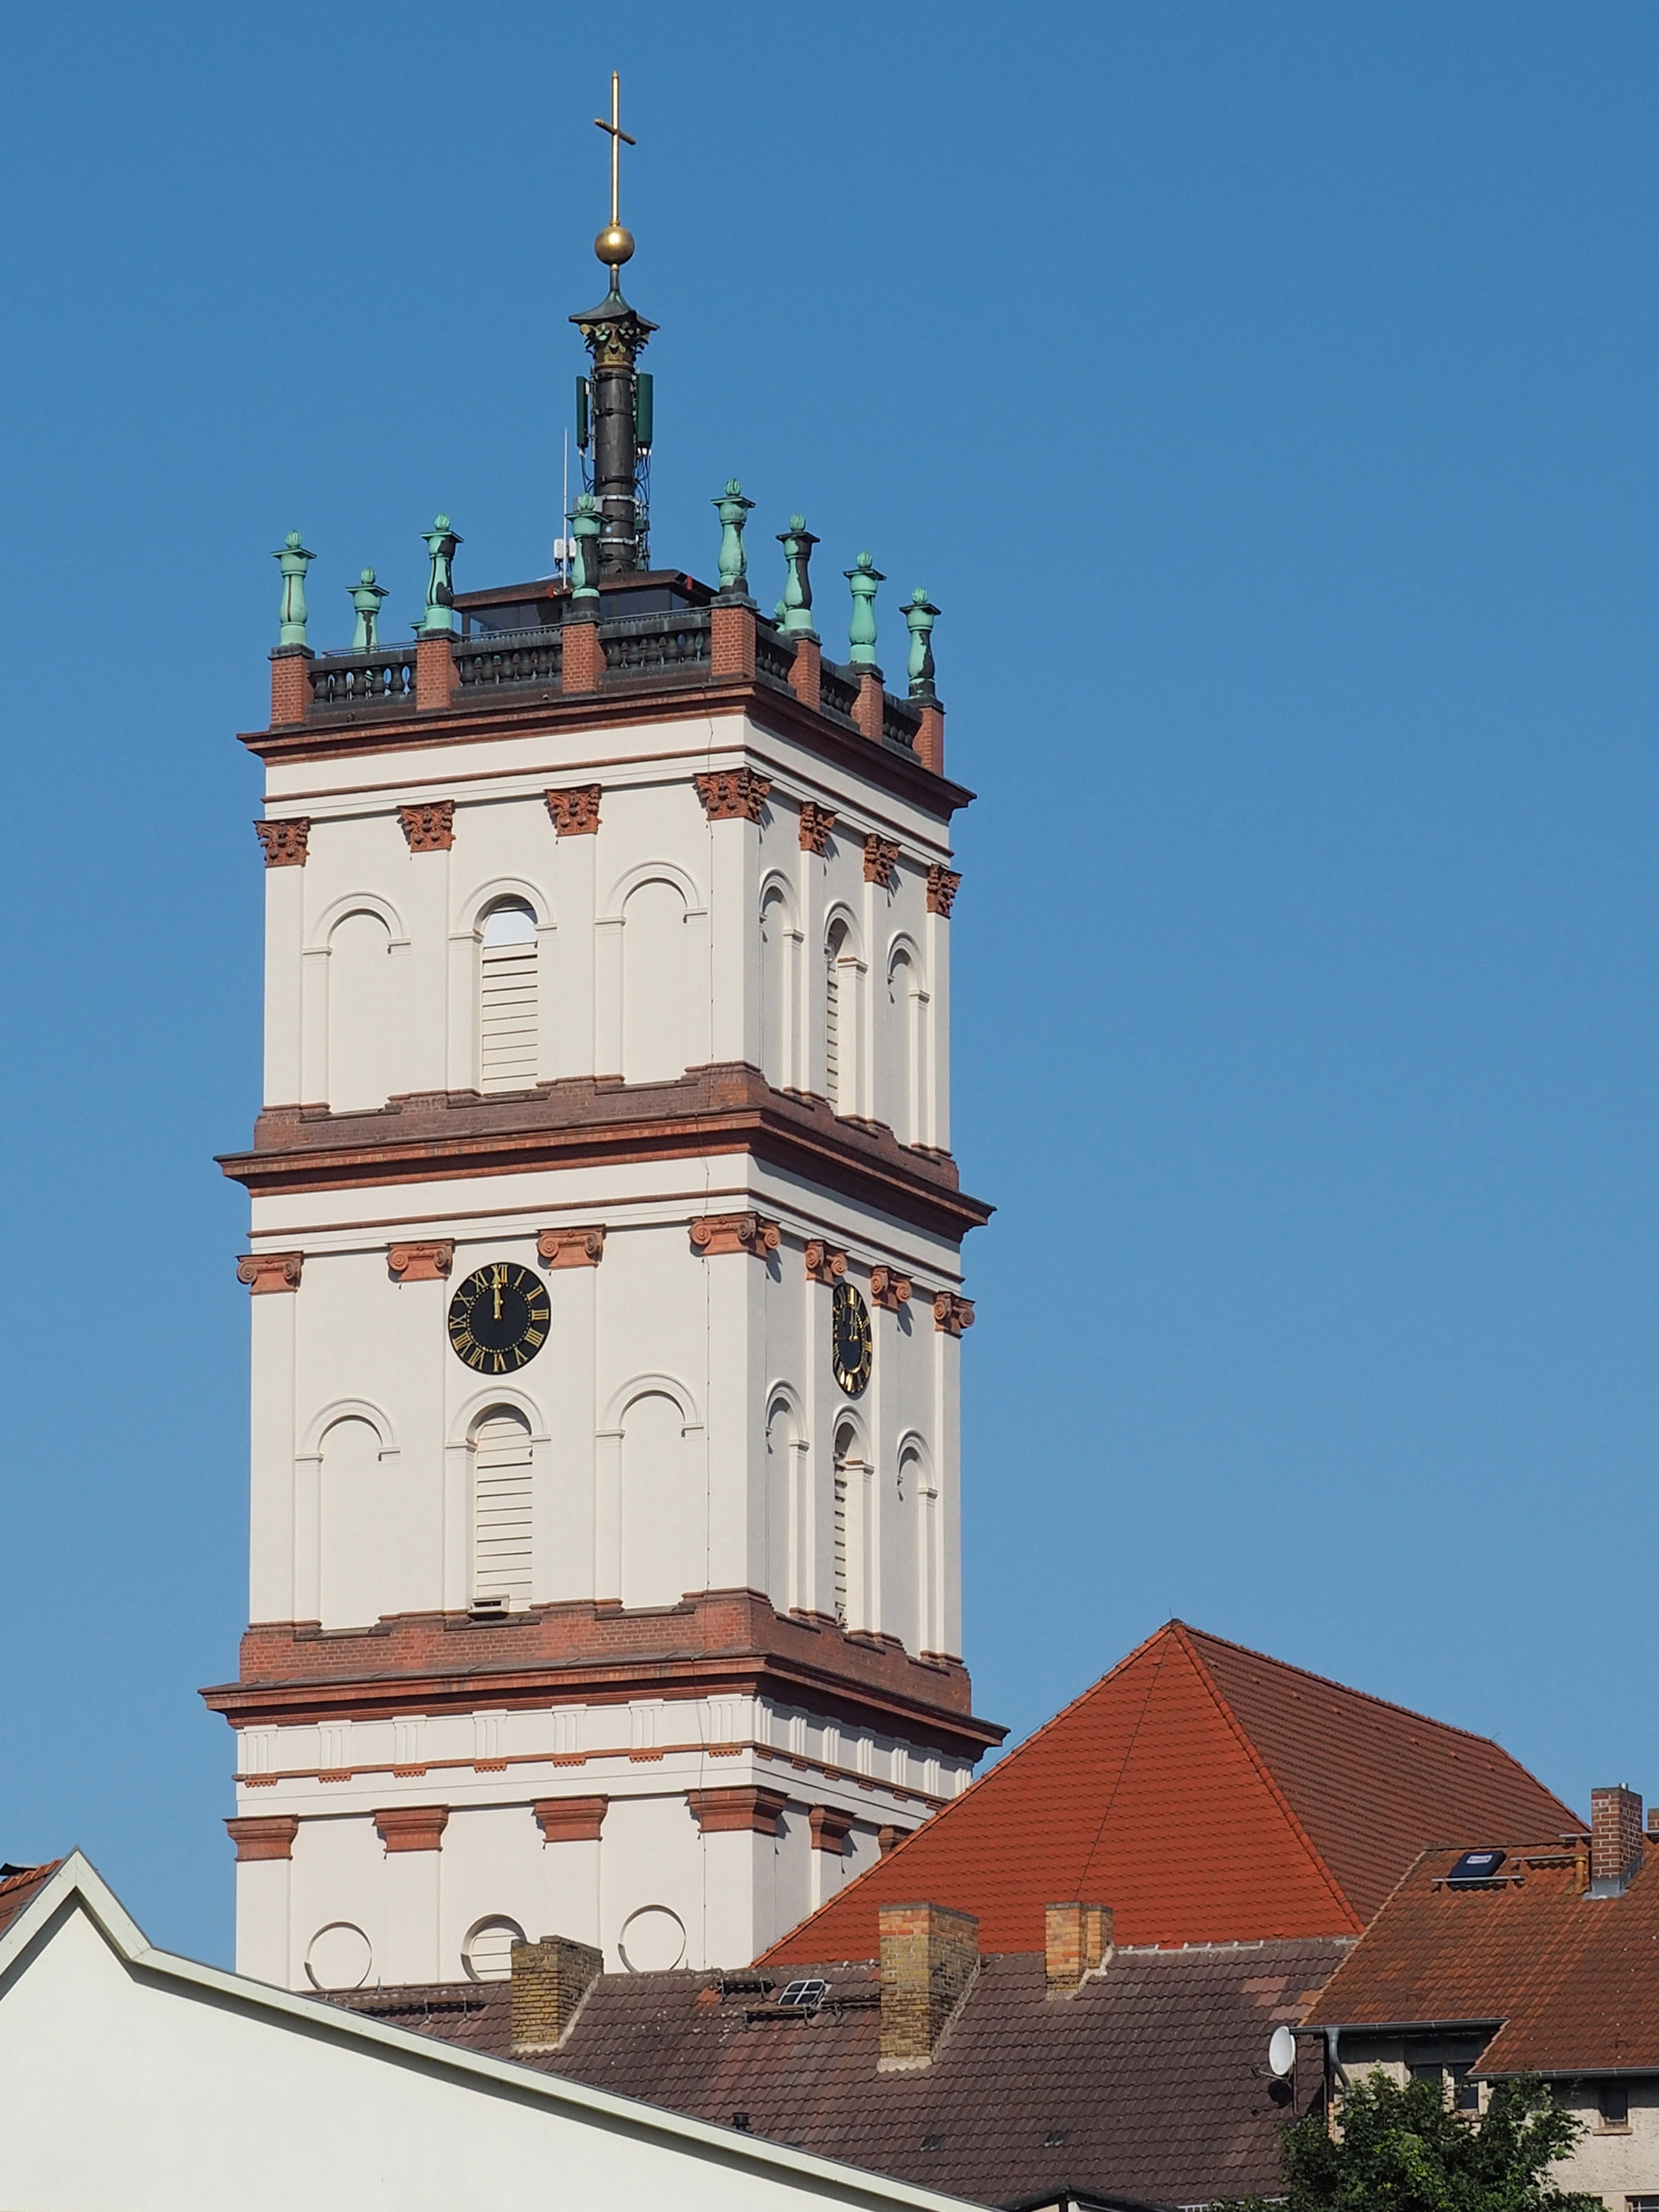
[571,69,657,575]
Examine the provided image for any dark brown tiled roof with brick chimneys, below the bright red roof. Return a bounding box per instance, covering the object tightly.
[336,1940,1347,2205]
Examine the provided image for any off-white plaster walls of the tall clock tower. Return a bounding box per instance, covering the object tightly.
[239,719,982,1980]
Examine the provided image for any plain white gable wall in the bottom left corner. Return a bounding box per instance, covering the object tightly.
[0,1907,982,2212]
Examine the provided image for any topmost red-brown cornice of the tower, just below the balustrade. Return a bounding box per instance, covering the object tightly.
[241,672,974,818]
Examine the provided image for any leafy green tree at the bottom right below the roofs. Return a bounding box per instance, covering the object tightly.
[1214,2073,1601,2212]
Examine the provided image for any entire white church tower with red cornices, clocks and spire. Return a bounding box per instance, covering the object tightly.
[206,88,1002,1989]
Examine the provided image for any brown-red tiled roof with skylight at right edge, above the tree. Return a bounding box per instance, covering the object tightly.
[1310,1834,1659,2075]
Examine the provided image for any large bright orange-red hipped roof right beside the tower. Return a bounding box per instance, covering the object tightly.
[765,1622,1579,1964]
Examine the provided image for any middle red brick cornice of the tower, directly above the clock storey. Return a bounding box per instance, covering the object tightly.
[219,1062,991,1241]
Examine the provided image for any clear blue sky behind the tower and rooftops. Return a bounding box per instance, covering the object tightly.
[0,0,1659,1958]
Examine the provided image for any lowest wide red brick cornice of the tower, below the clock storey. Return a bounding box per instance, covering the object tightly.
[201,1590,1004,1758]
